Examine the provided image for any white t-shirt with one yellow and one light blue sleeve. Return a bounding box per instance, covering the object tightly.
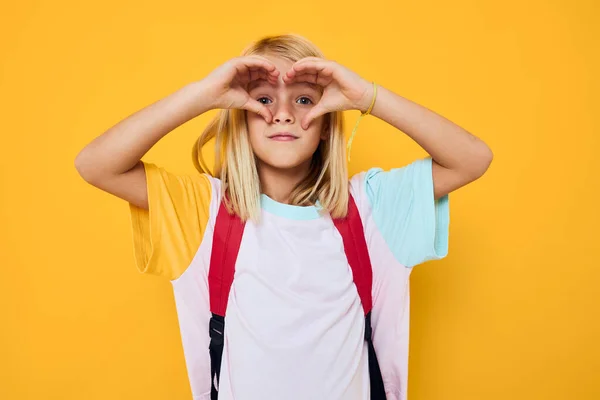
[130,157,449,400]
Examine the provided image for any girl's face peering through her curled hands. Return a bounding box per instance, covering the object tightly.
[246,56,326,170]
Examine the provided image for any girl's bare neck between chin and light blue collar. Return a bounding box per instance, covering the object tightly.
[257,160,310,204]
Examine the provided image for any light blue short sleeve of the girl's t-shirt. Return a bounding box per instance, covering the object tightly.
[365,157,450,268]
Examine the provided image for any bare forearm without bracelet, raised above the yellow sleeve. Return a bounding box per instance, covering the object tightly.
[75,81,210,180]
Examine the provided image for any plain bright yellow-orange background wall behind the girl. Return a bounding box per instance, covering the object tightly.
[0,0,600,400]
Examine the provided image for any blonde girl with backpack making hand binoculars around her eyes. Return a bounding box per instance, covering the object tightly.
[75,35,492,400]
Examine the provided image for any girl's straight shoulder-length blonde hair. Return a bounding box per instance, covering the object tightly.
[192,34,349,221]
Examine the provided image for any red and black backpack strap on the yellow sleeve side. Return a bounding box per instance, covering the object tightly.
[208,198,246,400]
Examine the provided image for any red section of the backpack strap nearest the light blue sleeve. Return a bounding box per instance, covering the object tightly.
[333,195,373,315]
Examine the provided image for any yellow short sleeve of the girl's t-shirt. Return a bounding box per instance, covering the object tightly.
[129,163,211,280]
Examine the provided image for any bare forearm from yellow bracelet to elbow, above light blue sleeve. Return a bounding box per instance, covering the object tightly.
[371,86,492,176]
